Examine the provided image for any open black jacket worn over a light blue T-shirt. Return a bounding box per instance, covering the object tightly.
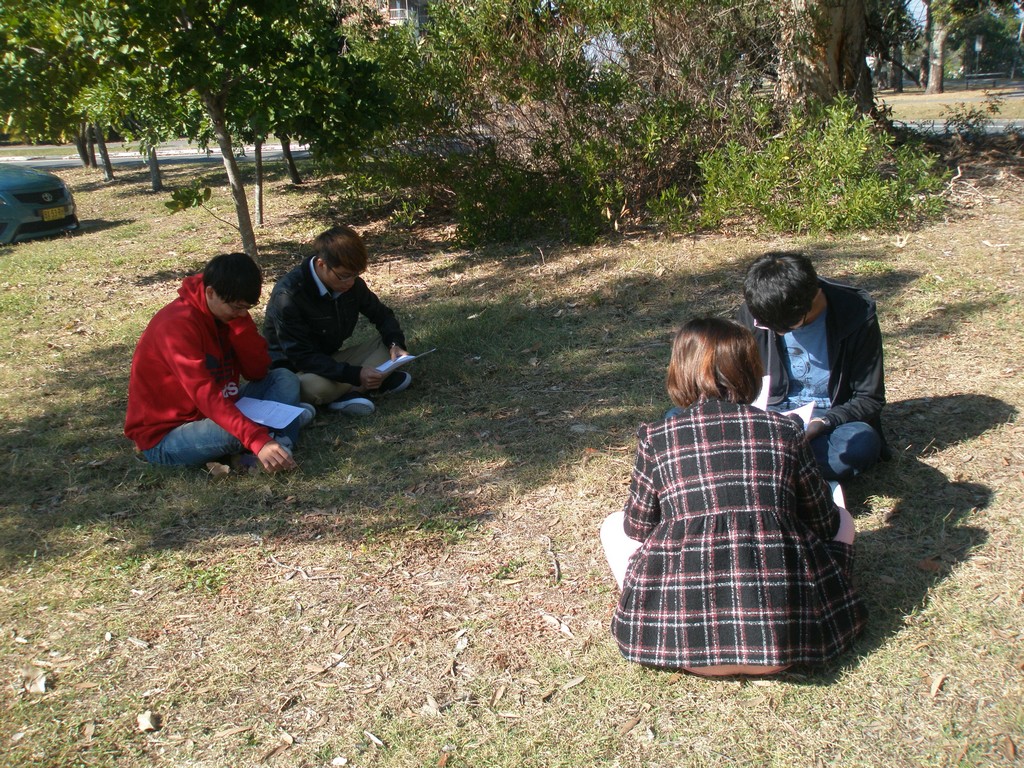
[737,279,888,455]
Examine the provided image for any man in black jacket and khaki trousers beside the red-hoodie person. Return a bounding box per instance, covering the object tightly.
[263,226,413,416]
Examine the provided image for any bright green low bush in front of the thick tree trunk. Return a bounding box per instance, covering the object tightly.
[699,100,945,232]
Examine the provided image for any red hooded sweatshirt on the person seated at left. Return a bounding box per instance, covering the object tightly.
[125,274,270,454]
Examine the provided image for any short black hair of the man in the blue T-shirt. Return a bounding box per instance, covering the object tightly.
[743,251,820,333]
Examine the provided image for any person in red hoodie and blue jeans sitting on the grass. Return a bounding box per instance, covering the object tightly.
[125,253,315,472]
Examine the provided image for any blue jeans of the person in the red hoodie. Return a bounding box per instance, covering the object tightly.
[142,368,299,467]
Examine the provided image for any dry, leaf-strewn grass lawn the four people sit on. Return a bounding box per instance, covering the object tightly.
[0,153,1024,768]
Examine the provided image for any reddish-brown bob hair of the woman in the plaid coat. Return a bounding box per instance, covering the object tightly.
[666,317,764,408]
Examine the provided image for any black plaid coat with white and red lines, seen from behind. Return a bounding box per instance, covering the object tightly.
[611,399,866,668]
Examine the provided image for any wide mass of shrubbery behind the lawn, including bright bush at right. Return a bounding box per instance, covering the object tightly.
[339,0,941,245]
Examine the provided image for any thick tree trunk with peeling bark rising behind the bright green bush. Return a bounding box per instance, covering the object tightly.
[779,0,873,112]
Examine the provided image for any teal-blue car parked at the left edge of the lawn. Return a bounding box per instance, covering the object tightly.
[0,163,78,243]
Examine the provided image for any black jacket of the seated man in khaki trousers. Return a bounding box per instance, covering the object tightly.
[263,257,406,386]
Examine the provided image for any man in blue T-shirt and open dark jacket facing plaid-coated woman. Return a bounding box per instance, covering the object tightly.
[737,252,888,480]
